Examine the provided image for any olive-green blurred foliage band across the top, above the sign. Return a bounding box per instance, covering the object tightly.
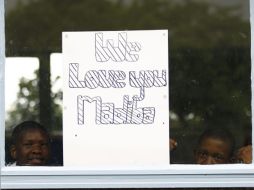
[6,0,250,53]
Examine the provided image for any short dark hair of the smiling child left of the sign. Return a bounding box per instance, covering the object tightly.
[12,121,50,145]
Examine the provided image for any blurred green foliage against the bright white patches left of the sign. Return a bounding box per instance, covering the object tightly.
[6,71,62,130]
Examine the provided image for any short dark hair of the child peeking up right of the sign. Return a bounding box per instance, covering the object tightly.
[198,127,235,156]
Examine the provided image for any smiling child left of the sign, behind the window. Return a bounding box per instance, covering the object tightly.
[10,121,50,166]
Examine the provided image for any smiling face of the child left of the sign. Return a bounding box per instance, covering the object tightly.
[11,129,50,166]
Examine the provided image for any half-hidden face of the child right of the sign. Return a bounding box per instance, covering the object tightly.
[195,137,230,164]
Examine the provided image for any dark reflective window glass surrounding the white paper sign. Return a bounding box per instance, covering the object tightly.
[5,0,252,166]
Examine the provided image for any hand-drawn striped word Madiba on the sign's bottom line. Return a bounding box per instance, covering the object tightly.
[77,95,155,125]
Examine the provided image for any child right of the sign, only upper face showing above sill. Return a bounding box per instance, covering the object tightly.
[195,128,235,164]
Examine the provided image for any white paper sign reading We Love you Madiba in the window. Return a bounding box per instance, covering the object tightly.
[63,30,169,167]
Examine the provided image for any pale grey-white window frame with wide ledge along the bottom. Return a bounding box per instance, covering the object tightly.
[0,1,254,189]
